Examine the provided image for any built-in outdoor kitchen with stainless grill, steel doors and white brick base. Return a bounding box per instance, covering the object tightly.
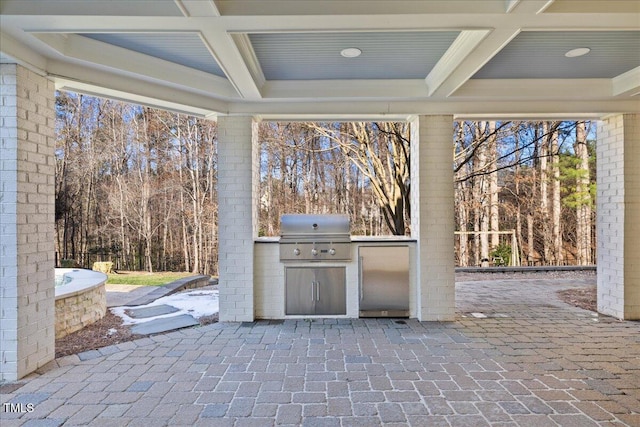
[254,215,417,319]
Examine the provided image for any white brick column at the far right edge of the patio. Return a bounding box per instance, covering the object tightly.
[596,114,640,320]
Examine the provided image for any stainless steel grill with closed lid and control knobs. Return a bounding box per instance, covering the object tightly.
[280,214,351,262]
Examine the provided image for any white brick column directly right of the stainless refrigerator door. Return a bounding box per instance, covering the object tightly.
[411,116,455,321]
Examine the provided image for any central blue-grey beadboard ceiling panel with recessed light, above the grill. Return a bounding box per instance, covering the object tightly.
[249,31,459,80]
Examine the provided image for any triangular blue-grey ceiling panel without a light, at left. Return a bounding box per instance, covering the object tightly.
[80,33,225,77]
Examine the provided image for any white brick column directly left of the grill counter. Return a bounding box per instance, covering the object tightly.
[218,117,259,322]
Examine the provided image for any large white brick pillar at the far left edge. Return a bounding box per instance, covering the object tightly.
[0,64,55,381]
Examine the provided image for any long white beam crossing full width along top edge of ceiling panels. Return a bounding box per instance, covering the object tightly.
[3,12,638,33]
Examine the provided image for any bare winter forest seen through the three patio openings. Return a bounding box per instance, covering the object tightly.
[55,92,595,275]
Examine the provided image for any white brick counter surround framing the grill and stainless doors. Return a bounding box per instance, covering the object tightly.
[253,236,416,319]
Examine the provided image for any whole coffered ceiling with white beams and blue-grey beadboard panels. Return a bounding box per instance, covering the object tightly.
[0,0,640,118]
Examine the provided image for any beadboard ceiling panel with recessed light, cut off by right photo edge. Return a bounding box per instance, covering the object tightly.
[473,31,640,79]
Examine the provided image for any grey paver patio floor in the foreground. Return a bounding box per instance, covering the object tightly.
[0,280,640,427]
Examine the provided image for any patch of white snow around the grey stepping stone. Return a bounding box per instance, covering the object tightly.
[111,289,220,325]
